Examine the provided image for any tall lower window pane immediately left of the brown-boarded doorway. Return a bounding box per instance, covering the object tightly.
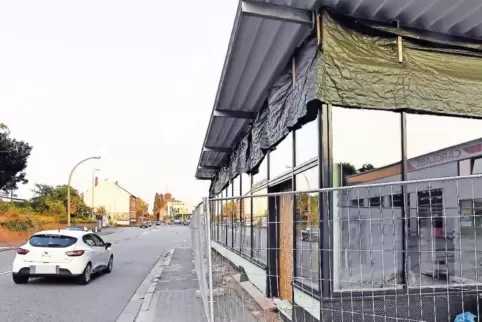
[252,188,268,264]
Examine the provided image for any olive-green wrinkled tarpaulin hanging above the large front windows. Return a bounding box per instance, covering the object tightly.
[316,13,482,117]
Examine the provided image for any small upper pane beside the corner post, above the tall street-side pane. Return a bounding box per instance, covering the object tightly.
[295,120,319,165]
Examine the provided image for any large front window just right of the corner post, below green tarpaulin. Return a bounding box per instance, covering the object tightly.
[332,107,403,291]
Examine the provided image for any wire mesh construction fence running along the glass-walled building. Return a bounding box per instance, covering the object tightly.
[193,175,482,322]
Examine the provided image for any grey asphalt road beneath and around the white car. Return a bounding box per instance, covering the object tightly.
[0,226,190,322]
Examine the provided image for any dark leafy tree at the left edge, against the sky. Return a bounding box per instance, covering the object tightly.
[0,123,32,191]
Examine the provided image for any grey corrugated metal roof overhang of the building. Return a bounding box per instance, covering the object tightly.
[196,0,482,179]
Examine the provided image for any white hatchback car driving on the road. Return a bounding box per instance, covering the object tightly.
[12,230,114,285]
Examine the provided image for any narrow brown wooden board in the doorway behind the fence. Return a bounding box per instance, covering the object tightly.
[277,182,293,303]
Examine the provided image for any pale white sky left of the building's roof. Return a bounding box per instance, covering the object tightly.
[0,0,238,208]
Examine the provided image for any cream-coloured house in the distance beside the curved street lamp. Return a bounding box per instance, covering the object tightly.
[84,177,137,226]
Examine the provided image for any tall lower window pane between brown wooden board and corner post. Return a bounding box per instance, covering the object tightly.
[295,167,320,290]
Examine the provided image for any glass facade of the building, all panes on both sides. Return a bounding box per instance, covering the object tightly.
[209,107,482,293]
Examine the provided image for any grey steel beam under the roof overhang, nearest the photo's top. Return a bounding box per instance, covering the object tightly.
[241,1,313,25]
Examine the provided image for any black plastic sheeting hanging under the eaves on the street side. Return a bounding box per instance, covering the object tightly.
[210,39,318,196]
